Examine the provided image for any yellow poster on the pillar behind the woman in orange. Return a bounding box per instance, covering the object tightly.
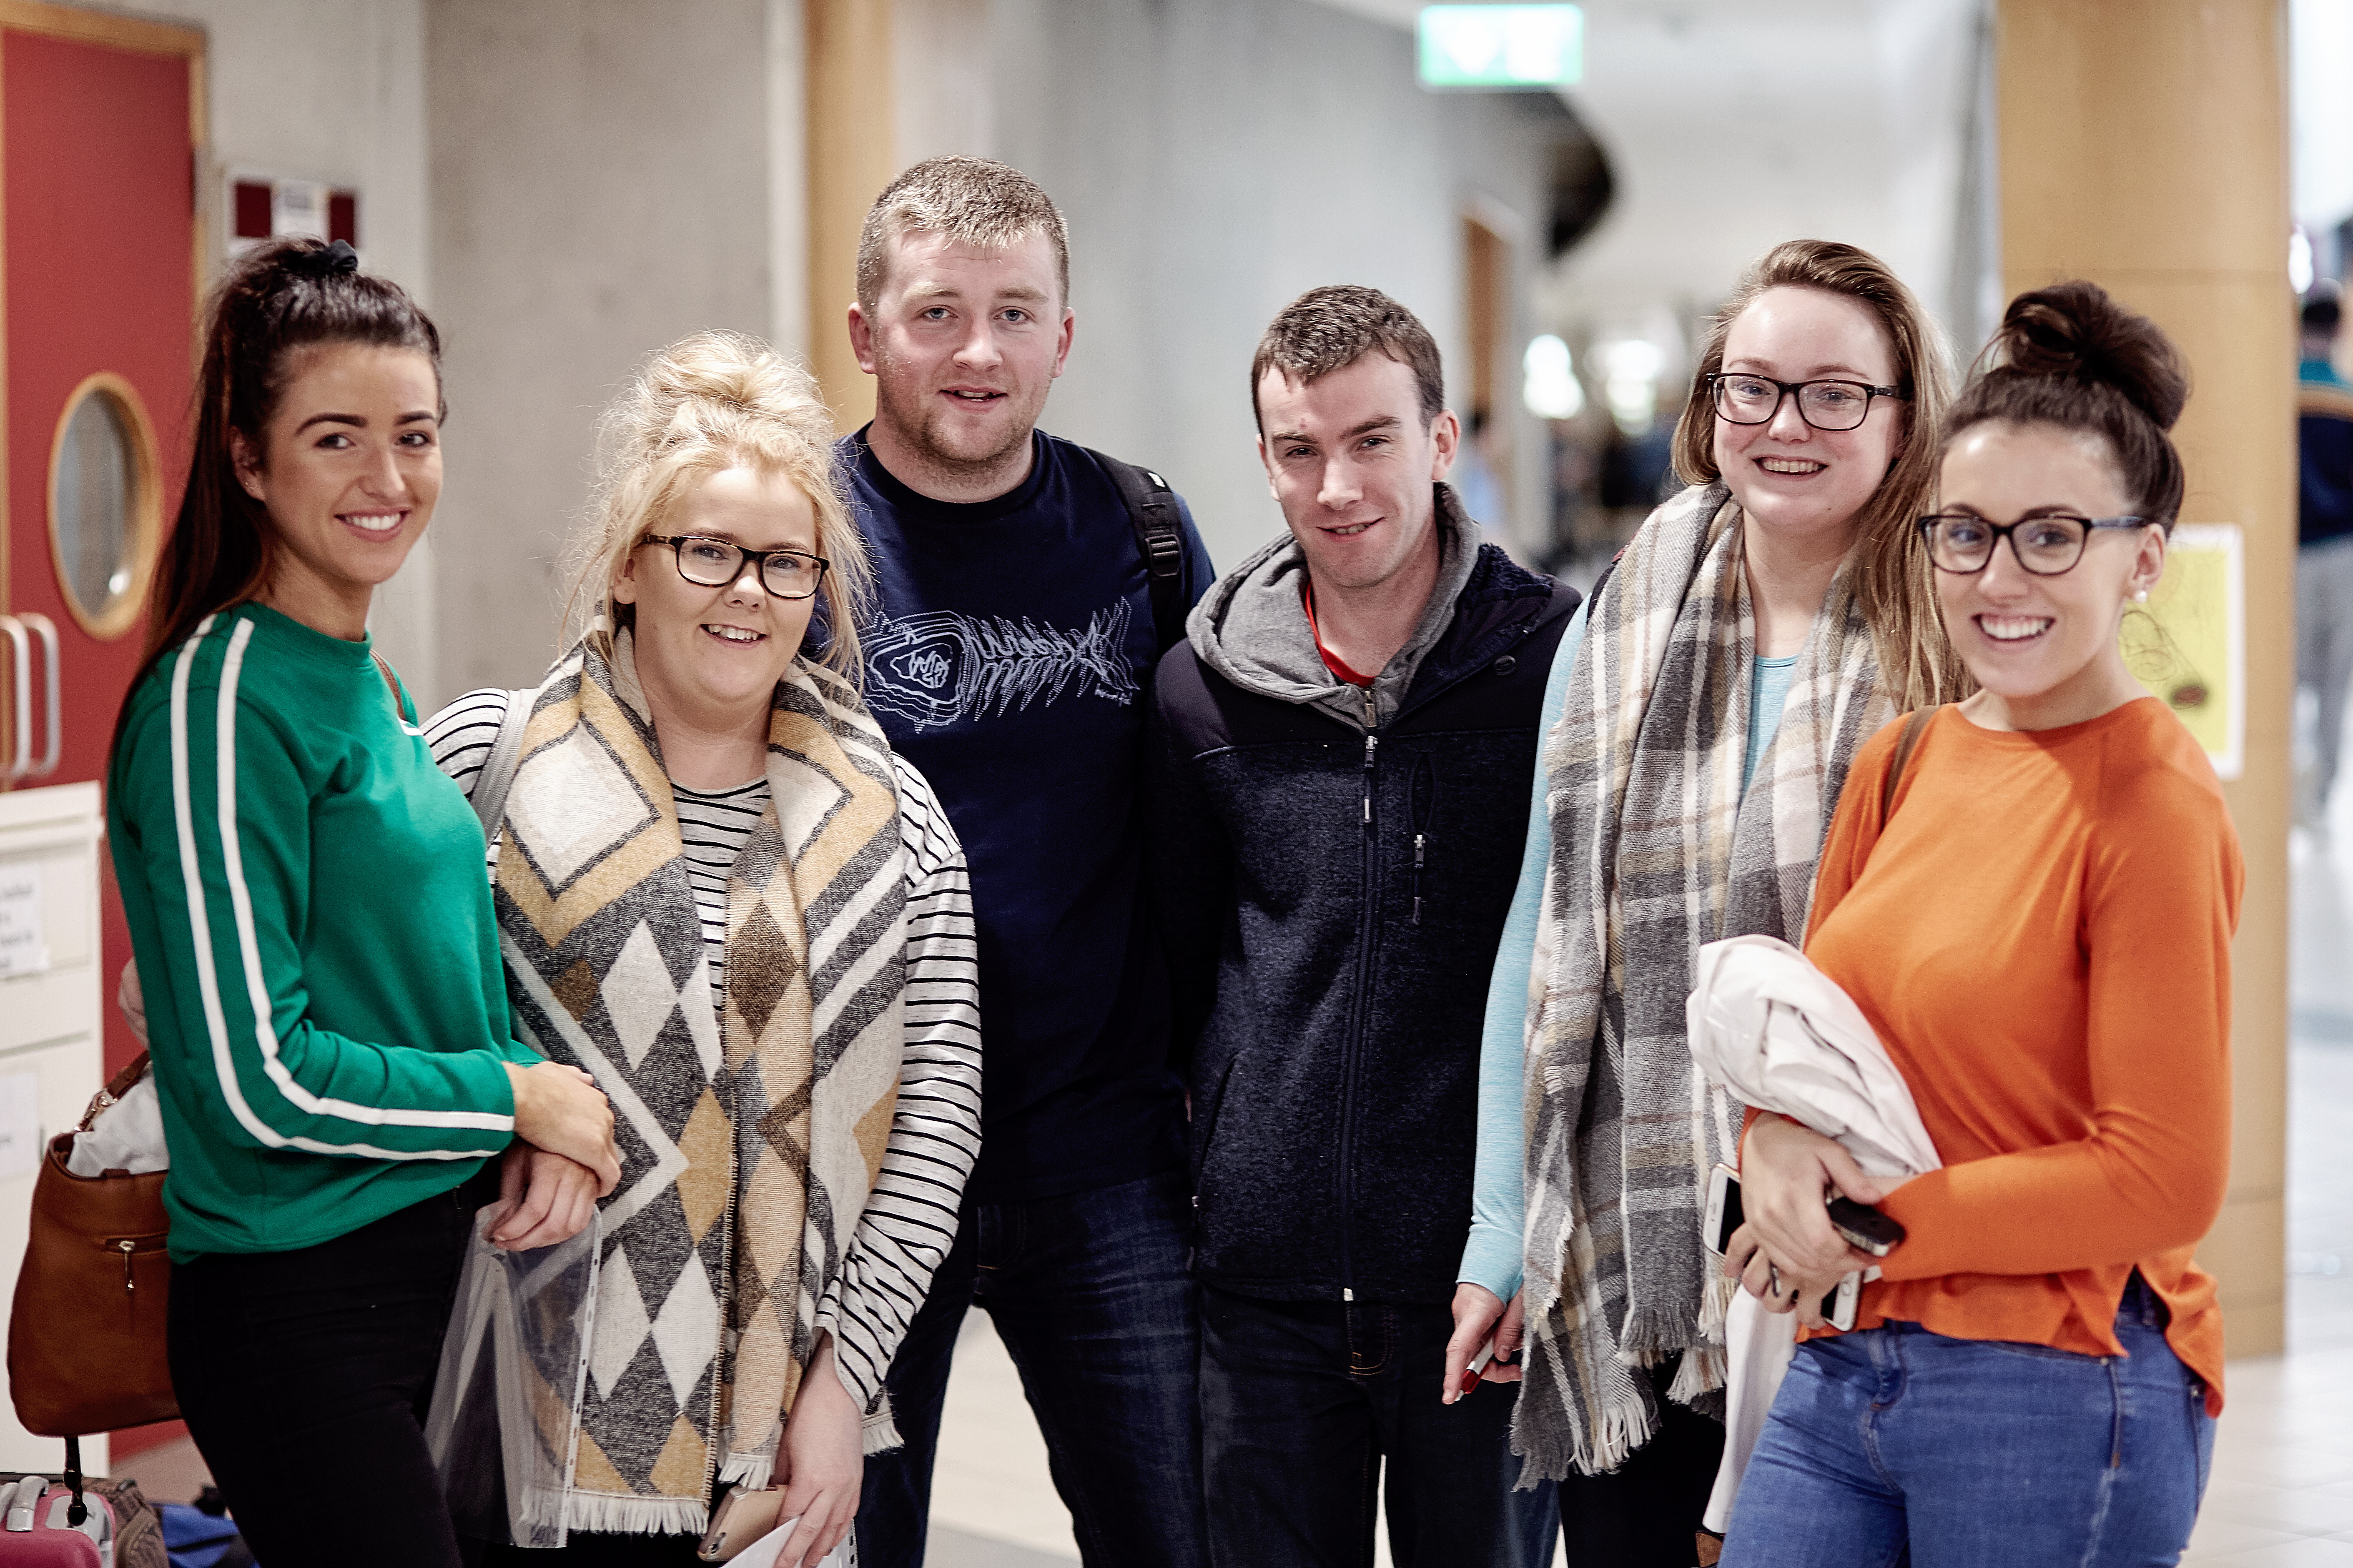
[2122,522,2247,778]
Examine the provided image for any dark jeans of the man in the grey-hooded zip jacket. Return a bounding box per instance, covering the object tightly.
[1200,1286,1560,1568]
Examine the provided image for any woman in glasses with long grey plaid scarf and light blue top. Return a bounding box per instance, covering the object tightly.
[1450,240,1960,1568]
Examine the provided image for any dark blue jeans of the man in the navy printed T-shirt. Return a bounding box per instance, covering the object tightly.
[859,1171,1207,1568]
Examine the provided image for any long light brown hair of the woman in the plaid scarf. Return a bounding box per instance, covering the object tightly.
[1676,240,1977,710]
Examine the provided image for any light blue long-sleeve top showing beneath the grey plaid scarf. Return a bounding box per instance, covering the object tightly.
[1457,599,1798,1302]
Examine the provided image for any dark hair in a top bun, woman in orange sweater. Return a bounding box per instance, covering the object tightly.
[1944,282,2191,534]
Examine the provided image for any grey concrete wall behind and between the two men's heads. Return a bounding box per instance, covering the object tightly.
[988,0,1572,566]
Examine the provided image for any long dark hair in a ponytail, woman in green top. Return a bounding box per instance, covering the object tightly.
[118,240,440,752]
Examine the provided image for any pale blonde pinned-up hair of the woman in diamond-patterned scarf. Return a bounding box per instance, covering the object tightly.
[565,331,873,684]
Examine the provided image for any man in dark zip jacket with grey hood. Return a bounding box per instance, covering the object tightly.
[1148,287,1576,1568]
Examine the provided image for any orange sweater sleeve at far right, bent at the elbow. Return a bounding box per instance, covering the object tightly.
[1864,769,2245,1279]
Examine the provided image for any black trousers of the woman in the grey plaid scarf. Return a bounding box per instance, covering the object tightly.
[1560,1356,1725,1568]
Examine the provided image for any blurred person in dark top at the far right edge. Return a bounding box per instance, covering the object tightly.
[2297,282,2353,827]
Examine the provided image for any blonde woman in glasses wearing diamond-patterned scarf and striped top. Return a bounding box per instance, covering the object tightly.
[426,334,981,1568]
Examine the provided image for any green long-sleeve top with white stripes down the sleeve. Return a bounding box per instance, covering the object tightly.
[106,604,539,1262]
